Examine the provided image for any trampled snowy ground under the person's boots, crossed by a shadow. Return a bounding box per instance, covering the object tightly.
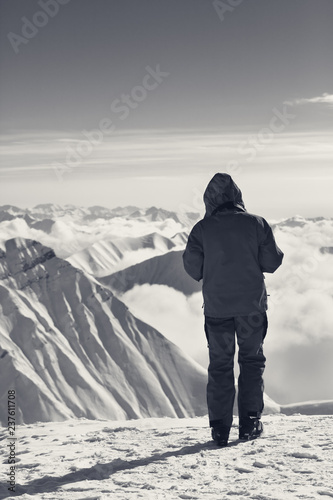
[0,414,333,500]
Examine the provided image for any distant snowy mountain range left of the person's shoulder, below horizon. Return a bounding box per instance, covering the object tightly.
[0,204,199,268]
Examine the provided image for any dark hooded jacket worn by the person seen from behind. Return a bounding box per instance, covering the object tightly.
[183,173,283,318]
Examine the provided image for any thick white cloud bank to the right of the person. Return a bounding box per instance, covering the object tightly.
[248,220,333,403]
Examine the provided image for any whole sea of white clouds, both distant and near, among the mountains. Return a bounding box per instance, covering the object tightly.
[0,212,333,404]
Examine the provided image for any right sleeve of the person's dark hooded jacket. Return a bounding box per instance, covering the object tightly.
[258,218,284,273]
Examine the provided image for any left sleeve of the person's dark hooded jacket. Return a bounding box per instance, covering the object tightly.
[183,224,204,281]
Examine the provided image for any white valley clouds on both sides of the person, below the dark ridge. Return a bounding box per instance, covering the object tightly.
[123,217,333,403]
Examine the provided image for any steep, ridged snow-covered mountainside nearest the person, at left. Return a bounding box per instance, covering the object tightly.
[0,238,206,424]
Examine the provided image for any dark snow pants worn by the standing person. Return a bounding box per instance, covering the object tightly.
[205,312,267,427]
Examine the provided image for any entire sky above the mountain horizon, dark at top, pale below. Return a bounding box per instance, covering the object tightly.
[0,0,333,219]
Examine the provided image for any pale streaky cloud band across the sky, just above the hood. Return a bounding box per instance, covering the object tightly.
[0,127,333,180]
